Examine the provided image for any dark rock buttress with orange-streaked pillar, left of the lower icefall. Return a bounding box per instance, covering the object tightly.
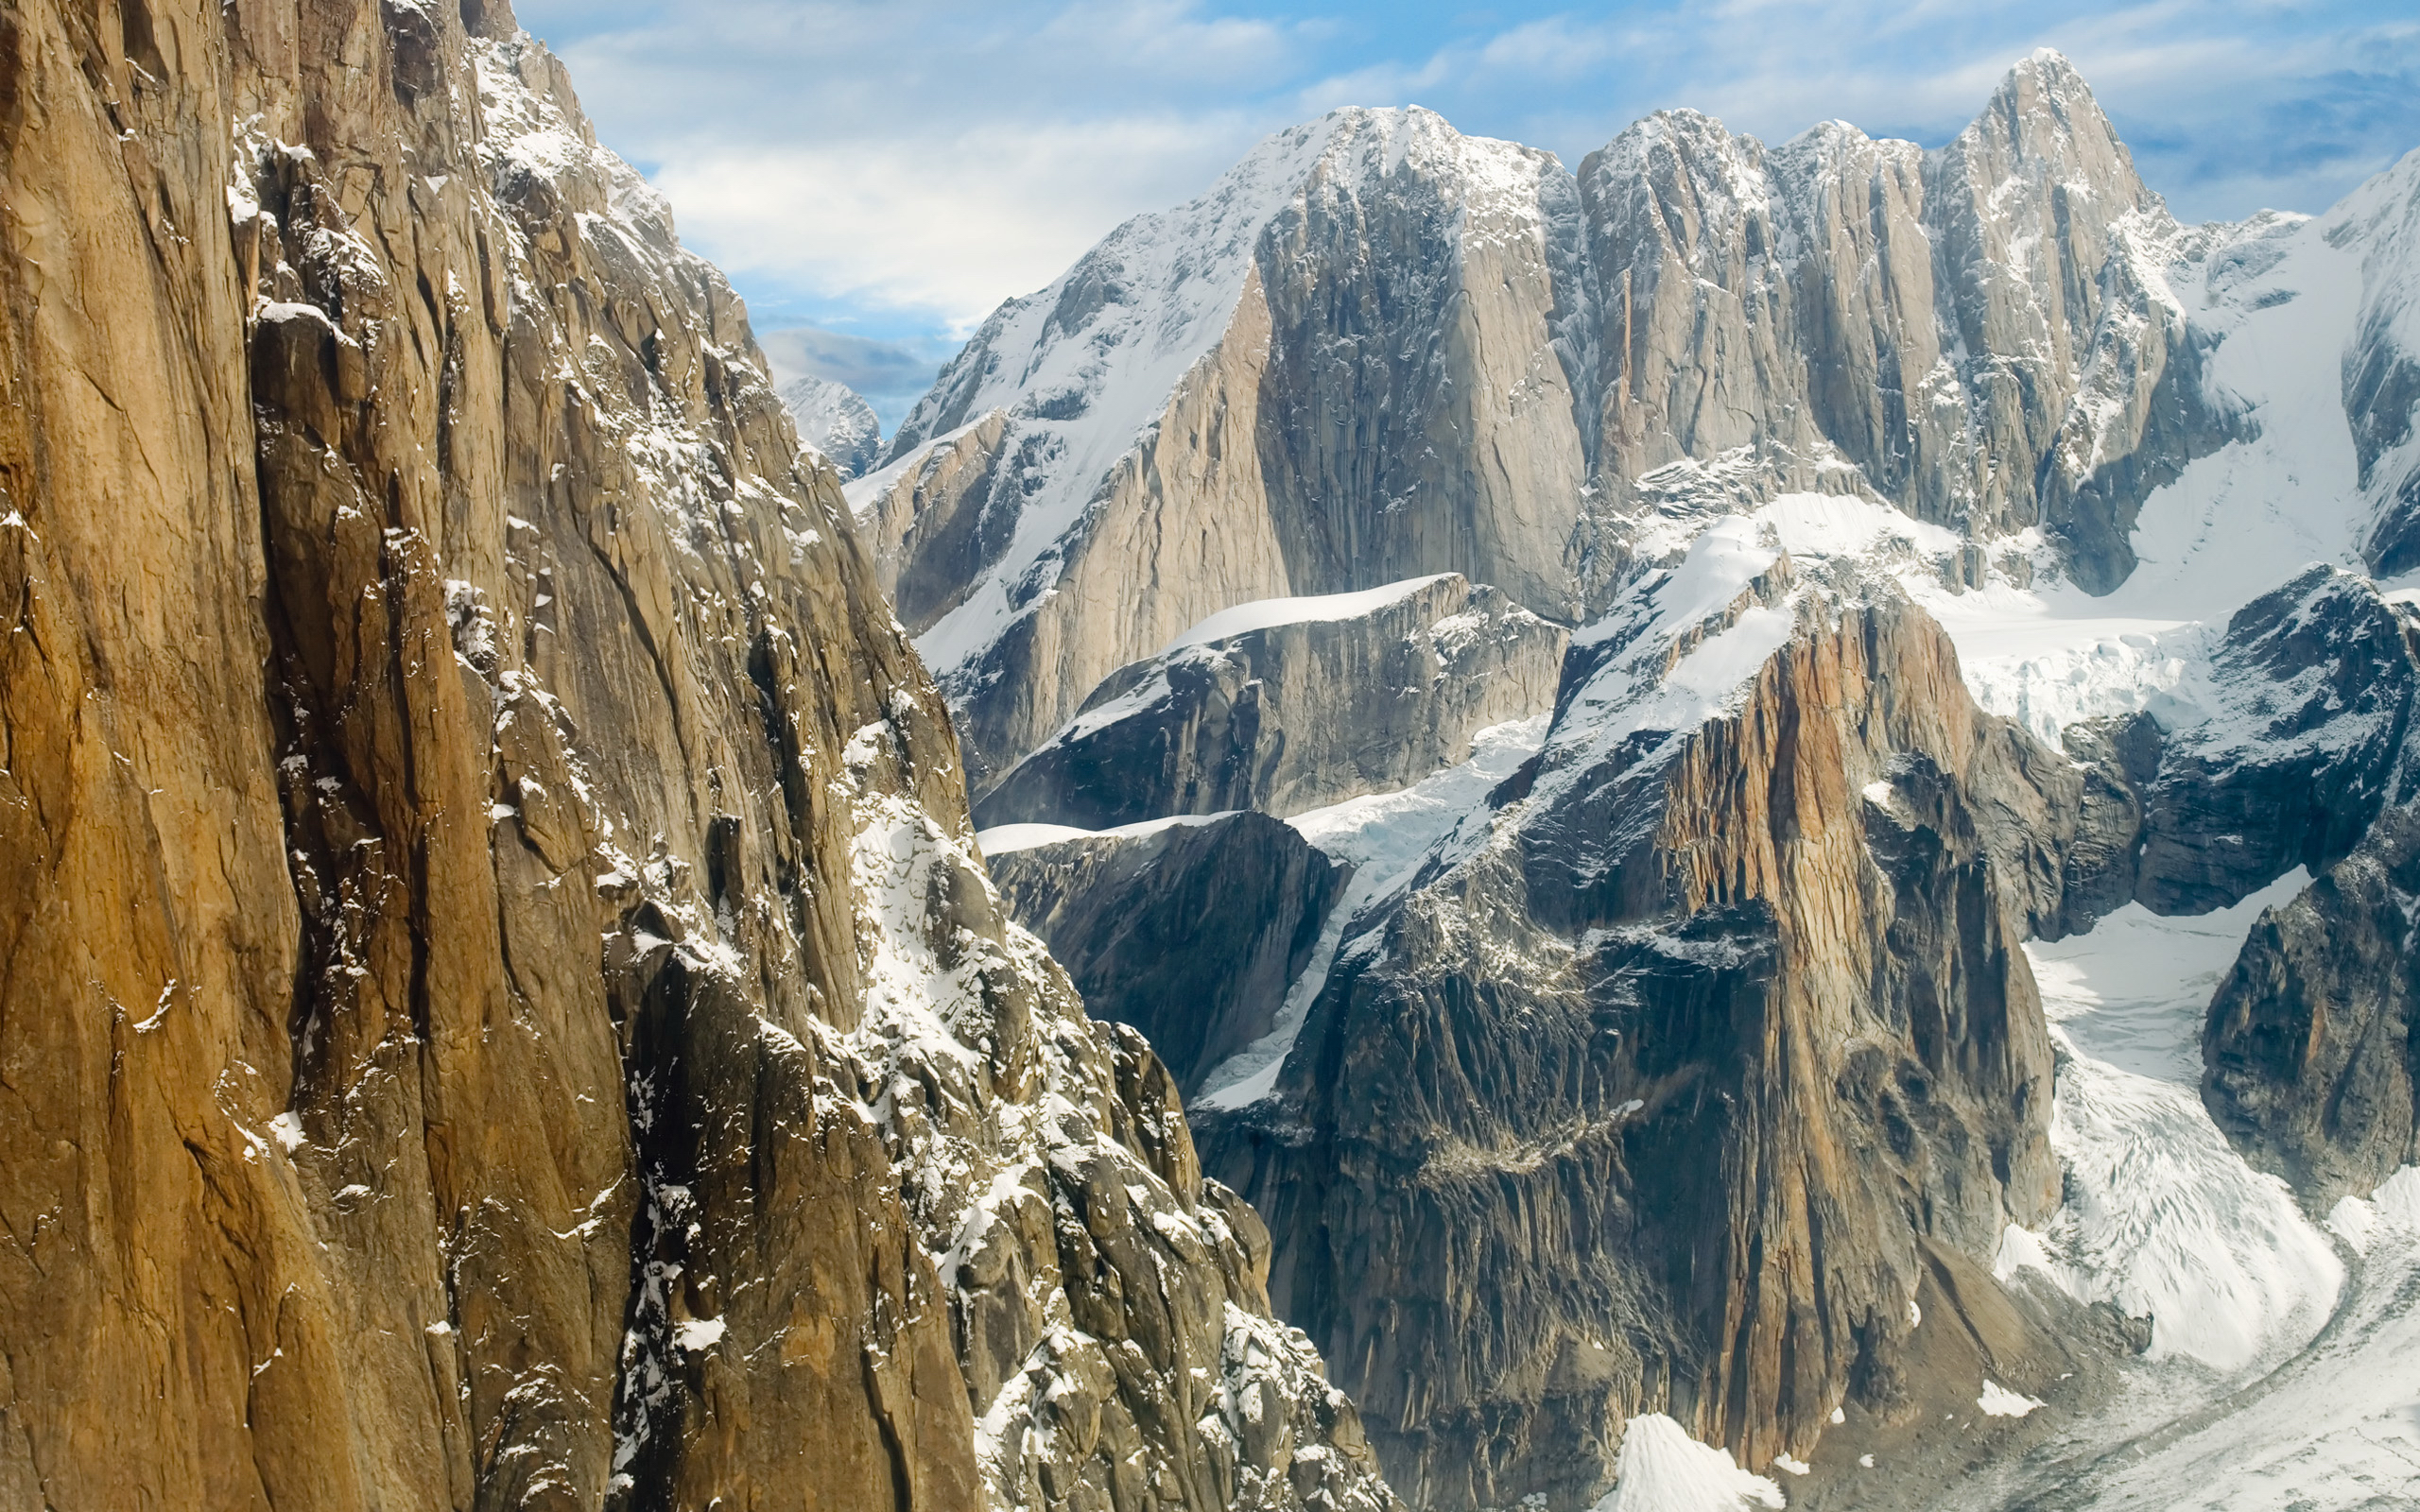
[1198,600,2060,1507]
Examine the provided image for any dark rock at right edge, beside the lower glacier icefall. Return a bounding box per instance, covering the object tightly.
[2203,808,2420,1212]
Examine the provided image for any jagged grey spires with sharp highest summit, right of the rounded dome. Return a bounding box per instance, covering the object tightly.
[1578,53,2231,582]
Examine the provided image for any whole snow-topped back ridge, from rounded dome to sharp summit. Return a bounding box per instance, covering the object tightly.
[852,53,2251,789]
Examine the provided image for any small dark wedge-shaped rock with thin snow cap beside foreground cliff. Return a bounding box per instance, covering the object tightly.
[990,813,1350,1098]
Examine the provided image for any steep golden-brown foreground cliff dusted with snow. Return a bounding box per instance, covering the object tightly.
[0,0,1387,1509]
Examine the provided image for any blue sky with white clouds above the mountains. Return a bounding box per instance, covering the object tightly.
[518,0,2420,428]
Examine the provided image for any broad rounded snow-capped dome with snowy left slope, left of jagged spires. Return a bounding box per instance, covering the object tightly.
[850,109,1585,791]
